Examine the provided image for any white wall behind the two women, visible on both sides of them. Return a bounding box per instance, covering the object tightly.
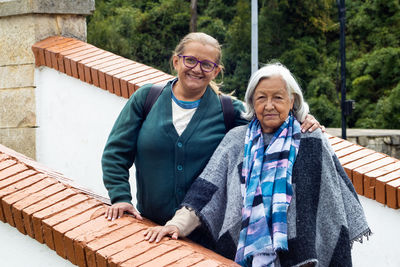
[32,67,400,267]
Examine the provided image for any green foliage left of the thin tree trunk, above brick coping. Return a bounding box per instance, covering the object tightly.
[88,0,190,72]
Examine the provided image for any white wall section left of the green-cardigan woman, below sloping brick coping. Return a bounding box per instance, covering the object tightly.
[35,67,136,203]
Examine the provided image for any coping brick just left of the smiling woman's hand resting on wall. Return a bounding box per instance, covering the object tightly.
[42,199,102,250]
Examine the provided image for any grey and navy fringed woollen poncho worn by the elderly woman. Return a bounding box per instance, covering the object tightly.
[182,126,371,266]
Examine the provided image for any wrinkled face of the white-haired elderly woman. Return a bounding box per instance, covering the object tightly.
[253,76,293,133]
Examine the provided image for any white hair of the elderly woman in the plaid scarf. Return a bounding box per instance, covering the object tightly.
[242,63,309,122]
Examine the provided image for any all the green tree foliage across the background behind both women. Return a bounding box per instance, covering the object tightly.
[88,0,400,128]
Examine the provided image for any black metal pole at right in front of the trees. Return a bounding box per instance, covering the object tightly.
[337,0,346,139]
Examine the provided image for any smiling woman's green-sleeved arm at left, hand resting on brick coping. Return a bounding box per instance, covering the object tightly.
[101,86,150,220]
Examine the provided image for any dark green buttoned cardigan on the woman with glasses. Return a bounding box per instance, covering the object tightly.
[102,81,248,224]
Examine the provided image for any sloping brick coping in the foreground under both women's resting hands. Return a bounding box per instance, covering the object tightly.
[0,145,237,267]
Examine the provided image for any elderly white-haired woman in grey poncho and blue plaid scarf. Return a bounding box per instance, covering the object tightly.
[145,63,370,266]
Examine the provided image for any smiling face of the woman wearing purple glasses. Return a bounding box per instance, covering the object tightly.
[172,41,221,101]
